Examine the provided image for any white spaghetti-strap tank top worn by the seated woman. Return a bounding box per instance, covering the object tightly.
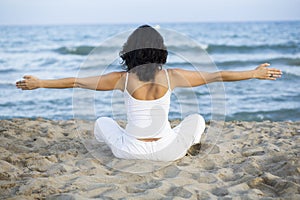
[124,70,171,139]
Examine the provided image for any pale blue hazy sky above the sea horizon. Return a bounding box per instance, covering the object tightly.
[0,0,300,25]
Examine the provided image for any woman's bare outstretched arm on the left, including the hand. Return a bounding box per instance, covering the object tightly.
[16,72,124,90]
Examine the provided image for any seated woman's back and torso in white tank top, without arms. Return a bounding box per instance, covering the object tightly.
[124,70,171,138]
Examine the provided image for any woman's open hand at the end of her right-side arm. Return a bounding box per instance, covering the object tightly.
[254,63,282,80]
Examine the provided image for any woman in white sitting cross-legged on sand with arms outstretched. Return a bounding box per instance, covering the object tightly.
[16,25,281,161]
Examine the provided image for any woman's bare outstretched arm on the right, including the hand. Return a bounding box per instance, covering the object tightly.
[171,63,282,88]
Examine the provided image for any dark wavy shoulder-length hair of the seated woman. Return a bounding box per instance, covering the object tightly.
[120,25,168,81]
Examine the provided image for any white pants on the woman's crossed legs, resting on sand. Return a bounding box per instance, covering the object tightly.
[94,114,205,161]
